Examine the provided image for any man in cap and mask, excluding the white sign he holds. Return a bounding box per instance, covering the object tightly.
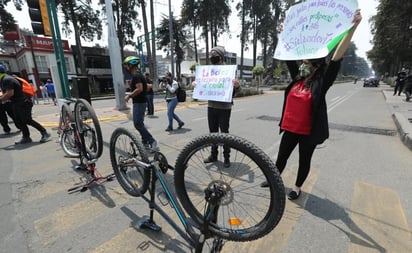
[192,47,240,168]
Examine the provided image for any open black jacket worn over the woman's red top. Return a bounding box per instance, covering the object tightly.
[279,60,341,144]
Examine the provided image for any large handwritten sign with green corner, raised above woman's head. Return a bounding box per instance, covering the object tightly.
[274,0,358,60]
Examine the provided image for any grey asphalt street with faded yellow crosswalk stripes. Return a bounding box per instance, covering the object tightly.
[0,84,412,253]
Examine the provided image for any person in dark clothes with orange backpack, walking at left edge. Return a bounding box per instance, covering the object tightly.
[0,64,51,144]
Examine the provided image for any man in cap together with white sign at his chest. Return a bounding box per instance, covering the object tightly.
[192,47,240,168]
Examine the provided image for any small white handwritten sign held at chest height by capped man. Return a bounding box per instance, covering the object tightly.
[193,65,236,102]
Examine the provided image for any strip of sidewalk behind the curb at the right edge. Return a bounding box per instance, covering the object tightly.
[382,85,412,151]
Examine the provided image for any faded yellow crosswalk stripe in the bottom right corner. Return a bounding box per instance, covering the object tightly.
[348,182,412,253]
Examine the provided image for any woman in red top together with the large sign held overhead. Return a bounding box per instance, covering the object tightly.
[261,0,362,200]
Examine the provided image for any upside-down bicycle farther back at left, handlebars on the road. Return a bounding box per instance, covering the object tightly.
[59,99,114,193]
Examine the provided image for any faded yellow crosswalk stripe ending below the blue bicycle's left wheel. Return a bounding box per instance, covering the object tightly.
[34,186,131,245]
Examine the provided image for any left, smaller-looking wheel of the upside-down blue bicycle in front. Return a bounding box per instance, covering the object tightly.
[110,128,150,197]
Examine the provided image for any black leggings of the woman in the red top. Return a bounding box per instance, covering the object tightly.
[276,131,316,187]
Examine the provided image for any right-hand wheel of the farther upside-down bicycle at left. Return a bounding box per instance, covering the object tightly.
[74,98,103,159]
